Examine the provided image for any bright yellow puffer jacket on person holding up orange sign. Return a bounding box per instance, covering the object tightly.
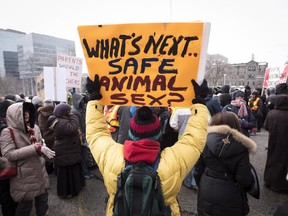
[86,100,208,216]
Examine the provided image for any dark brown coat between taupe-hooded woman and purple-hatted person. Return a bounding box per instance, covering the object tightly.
[38,106,55,150]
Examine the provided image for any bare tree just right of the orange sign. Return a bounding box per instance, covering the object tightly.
[205,61,228,86]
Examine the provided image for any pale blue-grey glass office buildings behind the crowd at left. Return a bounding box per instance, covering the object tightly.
[0,29,76,96]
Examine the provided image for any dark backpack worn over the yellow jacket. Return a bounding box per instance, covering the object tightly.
[113,158,171,216]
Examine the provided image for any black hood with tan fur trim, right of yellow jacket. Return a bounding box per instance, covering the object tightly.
[207,125,257,157]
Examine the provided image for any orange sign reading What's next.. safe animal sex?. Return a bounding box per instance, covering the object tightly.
[78,22,210,106]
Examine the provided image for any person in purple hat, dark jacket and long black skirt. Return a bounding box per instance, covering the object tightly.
[48,103,85,198]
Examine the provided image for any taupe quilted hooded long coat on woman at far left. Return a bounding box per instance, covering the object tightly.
[0,103,49,202]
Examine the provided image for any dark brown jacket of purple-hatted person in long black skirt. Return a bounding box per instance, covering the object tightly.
[48,114,82,166]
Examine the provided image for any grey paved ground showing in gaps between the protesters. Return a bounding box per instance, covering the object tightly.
[0,130,288,216]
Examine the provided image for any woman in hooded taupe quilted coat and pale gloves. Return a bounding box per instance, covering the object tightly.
[0,102,55,216]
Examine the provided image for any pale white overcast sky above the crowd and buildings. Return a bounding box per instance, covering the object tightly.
[0,0,288,72]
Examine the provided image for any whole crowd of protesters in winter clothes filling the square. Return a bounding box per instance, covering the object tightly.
[0,79,288,216]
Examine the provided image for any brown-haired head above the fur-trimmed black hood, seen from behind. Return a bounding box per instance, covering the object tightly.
[210,111,241,131]
